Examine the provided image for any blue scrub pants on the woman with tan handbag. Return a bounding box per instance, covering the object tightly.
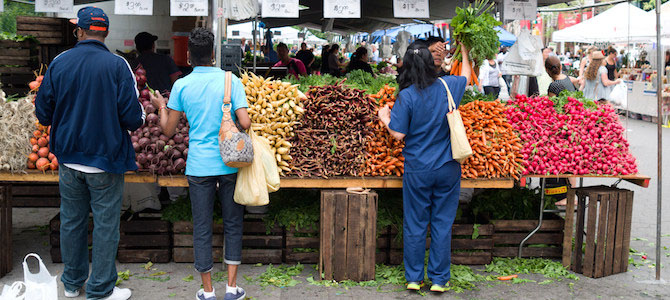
[402,160,461,285]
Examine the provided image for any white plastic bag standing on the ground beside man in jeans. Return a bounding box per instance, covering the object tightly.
[23,253,58,300]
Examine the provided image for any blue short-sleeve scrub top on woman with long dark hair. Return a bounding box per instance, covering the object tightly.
[389,76,467,172]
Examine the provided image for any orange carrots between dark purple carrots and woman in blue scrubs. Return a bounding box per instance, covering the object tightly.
[363,85,405,176]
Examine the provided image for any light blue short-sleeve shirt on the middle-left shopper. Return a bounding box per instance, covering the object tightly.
[167,67,248,177]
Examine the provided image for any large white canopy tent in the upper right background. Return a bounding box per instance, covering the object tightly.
[552,2,656,43]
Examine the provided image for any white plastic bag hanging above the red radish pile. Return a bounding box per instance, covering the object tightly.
[502,30,544,77]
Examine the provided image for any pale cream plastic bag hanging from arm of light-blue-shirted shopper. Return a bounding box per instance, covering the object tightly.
[233,131,276,206]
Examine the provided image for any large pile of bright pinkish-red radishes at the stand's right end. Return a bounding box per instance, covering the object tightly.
[506,95,637,175]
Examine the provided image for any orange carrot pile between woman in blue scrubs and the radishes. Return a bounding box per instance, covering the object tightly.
[458,100,523,180]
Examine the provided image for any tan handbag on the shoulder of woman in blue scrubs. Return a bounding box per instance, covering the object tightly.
[438,78,472,163]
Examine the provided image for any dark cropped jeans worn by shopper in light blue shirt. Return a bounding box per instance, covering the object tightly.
[187,173,244,273]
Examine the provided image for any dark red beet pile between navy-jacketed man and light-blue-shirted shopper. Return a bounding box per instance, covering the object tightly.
[130,66,188,175]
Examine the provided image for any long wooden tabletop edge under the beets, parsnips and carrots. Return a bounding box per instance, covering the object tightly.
[0,170,514,189]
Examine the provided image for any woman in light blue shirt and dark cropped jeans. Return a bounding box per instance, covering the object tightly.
[151,28,251,300]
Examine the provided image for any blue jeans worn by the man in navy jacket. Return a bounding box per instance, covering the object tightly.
[58,165,123,299]
